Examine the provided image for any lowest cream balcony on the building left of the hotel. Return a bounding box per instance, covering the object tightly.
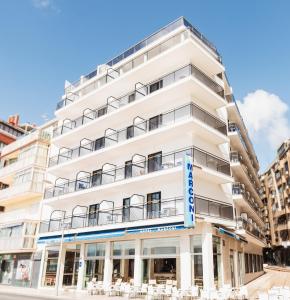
[0,221,38,253]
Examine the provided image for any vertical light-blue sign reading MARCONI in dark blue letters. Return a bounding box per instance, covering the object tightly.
[183,155,195,228]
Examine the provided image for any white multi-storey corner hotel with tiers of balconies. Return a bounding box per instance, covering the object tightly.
[38,18,264,289]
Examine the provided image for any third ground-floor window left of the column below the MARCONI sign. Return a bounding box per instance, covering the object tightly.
[84,243,106,286]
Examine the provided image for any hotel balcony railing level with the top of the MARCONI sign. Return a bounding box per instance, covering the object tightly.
[44,148,231,199]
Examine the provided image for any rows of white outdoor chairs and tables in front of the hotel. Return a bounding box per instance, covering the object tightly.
[87,278,249,300]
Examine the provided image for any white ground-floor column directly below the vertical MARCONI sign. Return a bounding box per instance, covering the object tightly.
[180,235,192,290]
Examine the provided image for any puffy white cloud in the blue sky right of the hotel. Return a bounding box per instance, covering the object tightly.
[237,90,290,150]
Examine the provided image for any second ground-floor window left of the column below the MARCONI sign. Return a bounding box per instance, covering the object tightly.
[111,241,135,282]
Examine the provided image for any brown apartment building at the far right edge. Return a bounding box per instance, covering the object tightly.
[261,140,290,266]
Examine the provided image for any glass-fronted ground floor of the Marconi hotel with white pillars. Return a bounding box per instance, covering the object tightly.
[37,223,245,289]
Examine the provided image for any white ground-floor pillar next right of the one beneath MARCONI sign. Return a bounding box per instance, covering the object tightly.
[202,223,214,290]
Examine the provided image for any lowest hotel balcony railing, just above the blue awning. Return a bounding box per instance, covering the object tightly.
[40,195,233,233]
